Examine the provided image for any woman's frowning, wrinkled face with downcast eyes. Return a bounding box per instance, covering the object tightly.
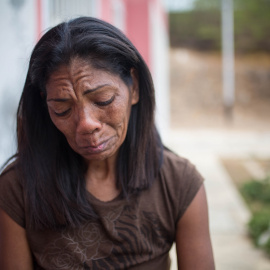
[46,58,139,160]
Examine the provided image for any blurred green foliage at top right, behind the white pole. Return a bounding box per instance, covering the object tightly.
[169,0,270,53]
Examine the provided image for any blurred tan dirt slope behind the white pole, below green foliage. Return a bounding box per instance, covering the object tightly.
[170,49,270,131]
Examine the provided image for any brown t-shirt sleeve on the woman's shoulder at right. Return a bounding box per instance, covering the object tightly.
[176,160,204,221]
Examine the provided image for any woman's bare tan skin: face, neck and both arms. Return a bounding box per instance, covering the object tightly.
[0,58,214,270]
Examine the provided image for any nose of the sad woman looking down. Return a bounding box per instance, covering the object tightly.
[76,107,102,135]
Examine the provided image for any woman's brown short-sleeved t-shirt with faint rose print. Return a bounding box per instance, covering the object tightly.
[0,150,203,270]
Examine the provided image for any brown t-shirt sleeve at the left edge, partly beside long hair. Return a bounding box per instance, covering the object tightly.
[0,164,25,228]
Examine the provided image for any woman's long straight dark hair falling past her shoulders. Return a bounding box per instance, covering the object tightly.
[17,17,162,229]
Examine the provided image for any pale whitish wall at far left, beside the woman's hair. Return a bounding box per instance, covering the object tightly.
[0,0,36,166]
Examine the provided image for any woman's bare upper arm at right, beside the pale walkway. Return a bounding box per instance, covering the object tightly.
[176,185,215,270]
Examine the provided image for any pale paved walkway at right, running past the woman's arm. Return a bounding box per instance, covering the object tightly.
[165,130,270,270]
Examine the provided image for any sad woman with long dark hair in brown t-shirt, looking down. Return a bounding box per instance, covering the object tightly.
[0,17,214,270]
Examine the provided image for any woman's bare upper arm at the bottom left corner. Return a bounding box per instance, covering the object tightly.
[0,208,33,270]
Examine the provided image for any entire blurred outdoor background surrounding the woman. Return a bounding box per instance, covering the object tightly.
[0,0,270,270]
